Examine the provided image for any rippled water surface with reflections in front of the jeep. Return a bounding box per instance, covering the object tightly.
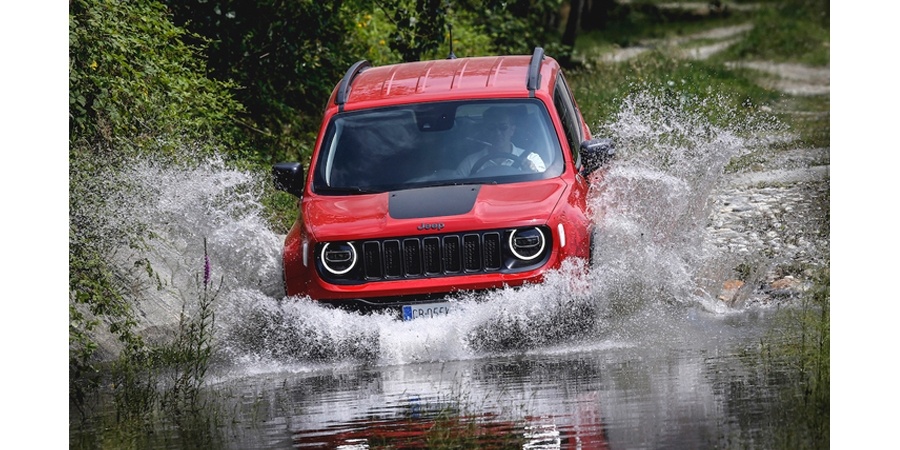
[73,302,808,449]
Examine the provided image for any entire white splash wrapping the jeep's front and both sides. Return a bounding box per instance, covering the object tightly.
[88,87,784,366]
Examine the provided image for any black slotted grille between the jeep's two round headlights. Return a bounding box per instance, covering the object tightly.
[362,231,502,281]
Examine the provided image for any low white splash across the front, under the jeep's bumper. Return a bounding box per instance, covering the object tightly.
[220,263,597,364]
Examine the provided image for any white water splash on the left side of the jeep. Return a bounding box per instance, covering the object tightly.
[81,157,283,347]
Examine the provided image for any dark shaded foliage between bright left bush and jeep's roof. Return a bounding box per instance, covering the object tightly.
[166,0,364,164]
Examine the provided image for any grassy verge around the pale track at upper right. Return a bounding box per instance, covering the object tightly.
[567,0,830,153]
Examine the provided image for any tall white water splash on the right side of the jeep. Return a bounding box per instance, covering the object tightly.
[591,88,783,315]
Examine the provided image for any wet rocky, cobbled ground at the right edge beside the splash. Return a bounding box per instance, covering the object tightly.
[708,148,830,305]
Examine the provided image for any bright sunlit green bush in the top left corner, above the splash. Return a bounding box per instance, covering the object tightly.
[69,0,248,156]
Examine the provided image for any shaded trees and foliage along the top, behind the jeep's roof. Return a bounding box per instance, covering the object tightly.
[159,0,562,164]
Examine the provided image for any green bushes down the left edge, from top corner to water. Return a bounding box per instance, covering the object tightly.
[69,0,245,414]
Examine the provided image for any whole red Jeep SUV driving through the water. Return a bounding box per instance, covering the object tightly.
[273,47,614,319]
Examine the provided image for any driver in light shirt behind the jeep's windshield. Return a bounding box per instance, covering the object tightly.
[456,106,547,176]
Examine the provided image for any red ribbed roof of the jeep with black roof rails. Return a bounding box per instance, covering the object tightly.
[328,47,559,110]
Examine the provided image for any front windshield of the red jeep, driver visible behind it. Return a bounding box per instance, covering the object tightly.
[313,99,563,195]
